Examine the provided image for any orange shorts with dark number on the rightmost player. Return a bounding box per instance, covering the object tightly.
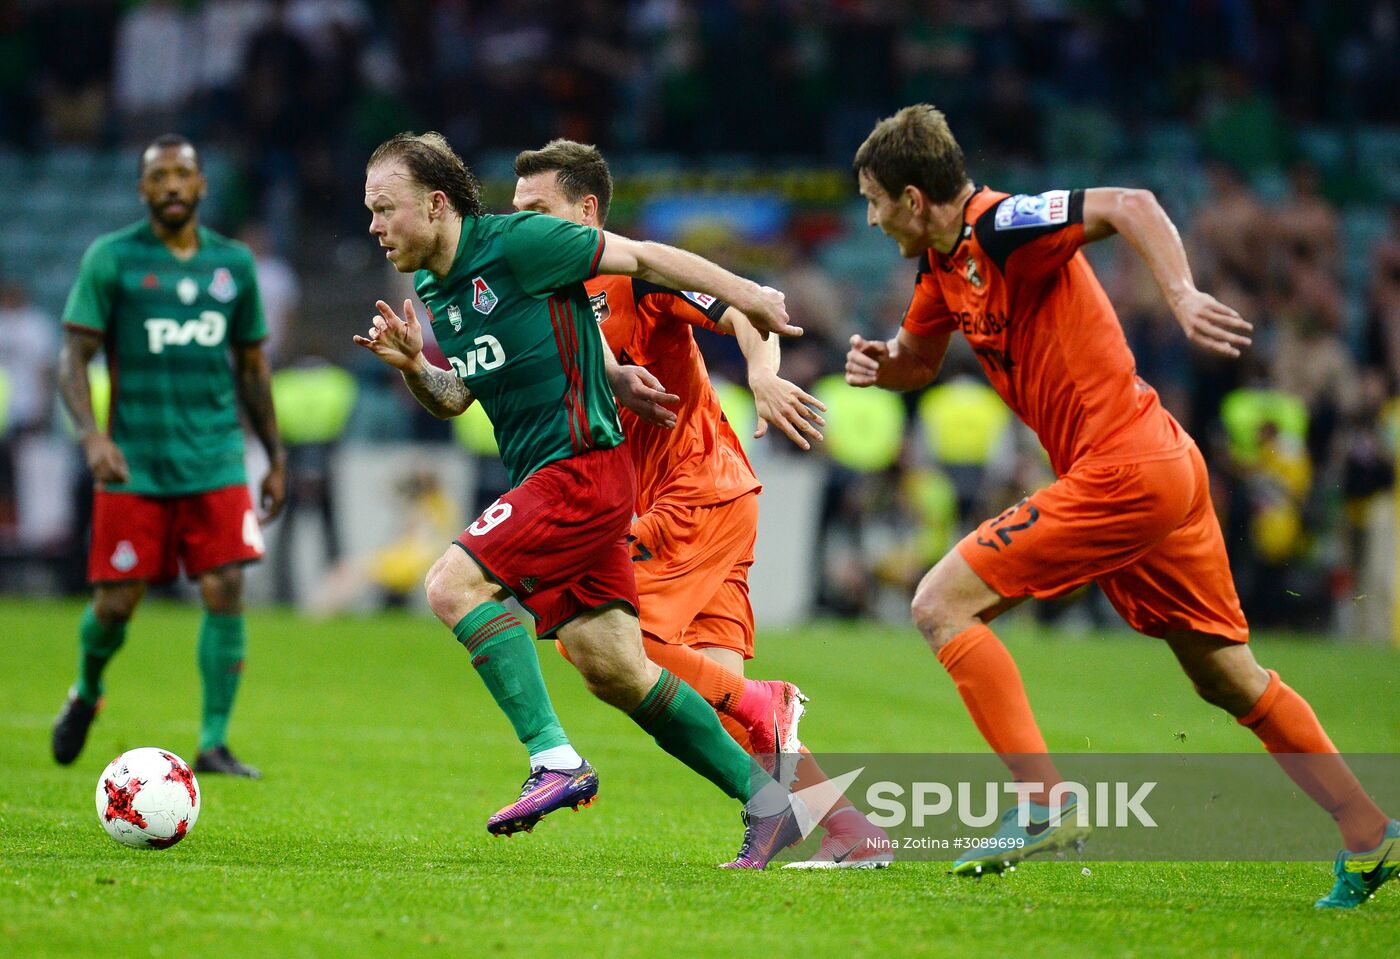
[958,444,1249,643]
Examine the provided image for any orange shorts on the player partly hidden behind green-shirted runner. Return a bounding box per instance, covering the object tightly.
[631,490,759,659]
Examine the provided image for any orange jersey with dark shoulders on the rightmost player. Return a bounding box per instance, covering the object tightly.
[903,186,1190,475]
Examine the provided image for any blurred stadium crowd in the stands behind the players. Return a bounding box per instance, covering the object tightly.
[0,0,1400,638]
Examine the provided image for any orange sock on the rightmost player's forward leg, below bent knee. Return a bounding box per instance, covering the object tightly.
[938,623,1060,804]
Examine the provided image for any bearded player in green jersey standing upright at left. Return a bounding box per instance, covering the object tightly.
[53,134,287,778]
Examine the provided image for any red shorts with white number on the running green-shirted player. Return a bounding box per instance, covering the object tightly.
[455,447,637,640]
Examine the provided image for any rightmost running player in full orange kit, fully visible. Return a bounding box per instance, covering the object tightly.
[846,104,1400,907]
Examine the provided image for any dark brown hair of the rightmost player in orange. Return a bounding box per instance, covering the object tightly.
[851,104,967,203]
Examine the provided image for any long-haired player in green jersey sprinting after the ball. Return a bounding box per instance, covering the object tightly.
[356,133,805,869]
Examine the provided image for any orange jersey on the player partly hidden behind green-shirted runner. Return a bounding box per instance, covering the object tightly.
[585,276,760,515]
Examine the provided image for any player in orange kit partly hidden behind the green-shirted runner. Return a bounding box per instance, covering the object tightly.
[514,140,889,868]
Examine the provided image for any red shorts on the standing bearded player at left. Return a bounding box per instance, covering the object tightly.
[88,483,263,582]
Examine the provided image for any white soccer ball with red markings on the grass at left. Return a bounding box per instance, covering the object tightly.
[97,746,199,850]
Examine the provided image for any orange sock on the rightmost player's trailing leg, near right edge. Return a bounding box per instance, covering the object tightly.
[1239,669,1387,853]
